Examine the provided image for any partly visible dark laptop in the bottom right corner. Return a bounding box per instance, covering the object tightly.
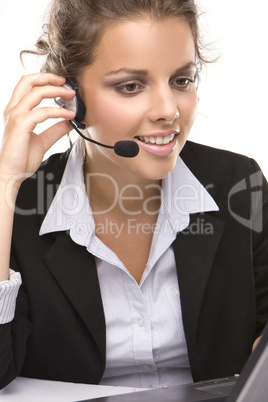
[76,324,268,402]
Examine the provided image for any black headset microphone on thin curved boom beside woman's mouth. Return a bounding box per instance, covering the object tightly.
[69,120,140,158]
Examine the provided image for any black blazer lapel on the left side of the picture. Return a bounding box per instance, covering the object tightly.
[43,232,106,361]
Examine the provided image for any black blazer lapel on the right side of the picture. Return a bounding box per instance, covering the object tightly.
[173,213,224,346]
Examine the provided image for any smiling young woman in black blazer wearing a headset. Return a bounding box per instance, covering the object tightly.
[0,0,268,387]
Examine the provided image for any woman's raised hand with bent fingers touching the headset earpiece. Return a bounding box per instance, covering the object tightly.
[0,73,75,187]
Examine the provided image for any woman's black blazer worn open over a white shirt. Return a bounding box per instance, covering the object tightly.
[0,142,268,387]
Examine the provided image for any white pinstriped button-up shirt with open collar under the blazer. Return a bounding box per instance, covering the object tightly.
[1,141,218,388]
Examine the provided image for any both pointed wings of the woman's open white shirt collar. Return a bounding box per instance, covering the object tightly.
[39,140,219,246]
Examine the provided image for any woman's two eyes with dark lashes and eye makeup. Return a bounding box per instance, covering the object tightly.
[115,76,196,96]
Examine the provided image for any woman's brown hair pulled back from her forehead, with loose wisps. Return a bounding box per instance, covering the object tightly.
[22,0,207,81]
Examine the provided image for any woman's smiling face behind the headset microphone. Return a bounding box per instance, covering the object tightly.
[81,17,198,180]
